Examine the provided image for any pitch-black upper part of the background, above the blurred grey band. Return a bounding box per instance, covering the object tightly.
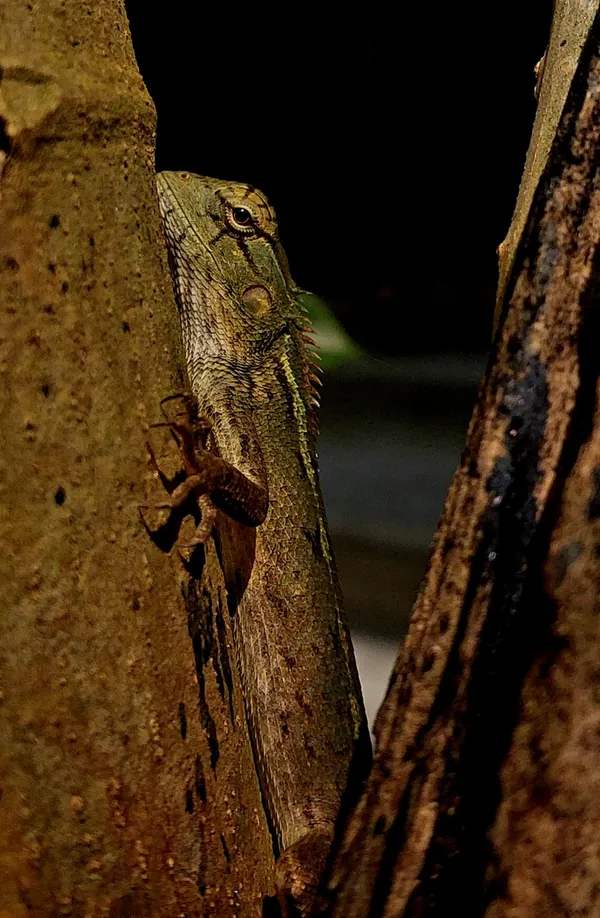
[126,0,551,354]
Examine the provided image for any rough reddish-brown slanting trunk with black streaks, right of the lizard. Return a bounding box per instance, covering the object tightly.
[331,7,600,918]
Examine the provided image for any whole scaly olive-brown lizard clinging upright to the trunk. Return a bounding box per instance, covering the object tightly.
[157,172,371,914]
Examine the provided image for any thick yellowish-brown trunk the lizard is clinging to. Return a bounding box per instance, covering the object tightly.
[0,0,273,918]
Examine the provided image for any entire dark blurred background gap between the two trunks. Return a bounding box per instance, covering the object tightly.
[126,0,552,718]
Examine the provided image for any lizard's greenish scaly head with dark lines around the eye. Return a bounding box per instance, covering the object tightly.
[157,172,316,416]
